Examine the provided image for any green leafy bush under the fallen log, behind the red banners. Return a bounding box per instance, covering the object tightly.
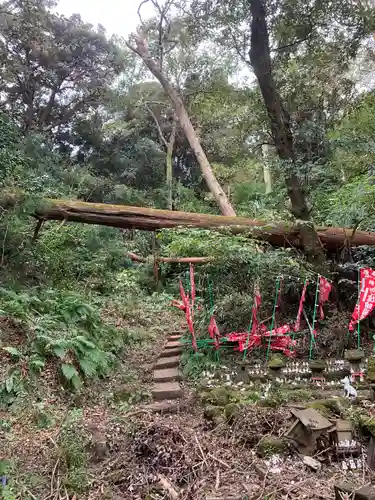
[159,230,310,331]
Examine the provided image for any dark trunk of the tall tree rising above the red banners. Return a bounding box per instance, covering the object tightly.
[249,0,325,263]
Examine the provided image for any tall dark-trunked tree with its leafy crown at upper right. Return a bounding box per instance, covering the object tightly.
[192,0,371,254]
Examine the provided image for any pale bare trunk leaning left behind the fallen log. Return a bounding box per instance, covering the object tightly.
[127,36,236,215]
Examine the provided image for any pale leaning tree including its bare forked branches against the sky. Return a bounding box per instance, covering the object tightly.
[127,0,236,216]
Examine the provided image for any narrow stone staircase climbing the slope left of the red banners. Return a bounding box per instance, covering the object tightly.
[148,333,183,413]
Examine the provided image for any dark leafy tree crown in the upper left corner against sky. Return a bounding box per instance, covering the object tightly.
[0,0,123,132]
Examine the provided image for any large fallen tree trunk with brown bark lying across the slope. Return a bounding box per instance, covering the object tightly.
[5,195,375,250]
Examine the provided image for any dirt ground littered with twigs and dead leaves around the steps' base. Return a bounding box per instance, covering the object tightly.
[0,306,375,500]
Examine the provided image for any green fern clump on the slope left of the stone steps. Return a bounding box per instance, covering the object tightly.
[0,288,127,399]
